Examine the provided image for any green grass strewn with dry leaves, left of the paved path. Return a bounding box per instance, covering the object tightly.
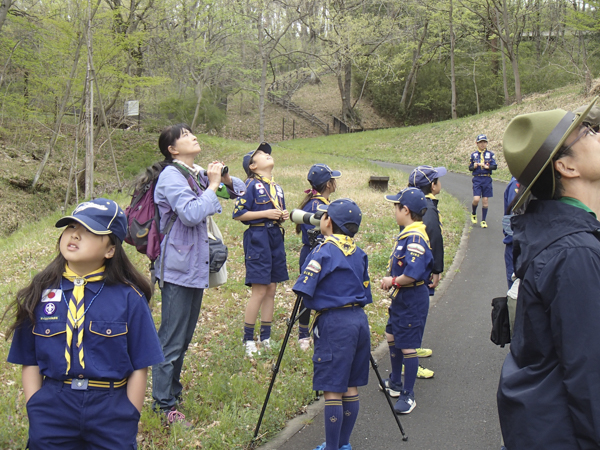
[0,131,466,449]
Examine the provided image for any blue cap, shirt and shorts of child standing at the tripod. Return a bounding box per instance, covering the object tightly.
[293,199,373,392]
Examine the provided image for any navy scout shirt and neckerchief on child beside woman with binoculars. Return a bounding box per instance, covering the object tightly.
[232,177,286,225]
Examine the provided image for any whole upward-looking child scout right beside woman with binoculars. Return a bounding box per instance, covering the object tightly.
[233,142,290,357]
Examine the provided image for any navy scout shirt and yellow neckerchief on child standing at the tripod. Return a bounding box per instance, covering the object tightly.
[292,234,373,311]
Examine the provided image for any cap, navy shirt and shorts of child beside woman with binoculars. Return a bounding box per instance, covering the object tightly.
[233,144,289,286]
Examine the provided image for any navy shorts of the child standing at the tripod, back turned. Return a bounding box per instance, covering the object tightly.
[313,306,371,393]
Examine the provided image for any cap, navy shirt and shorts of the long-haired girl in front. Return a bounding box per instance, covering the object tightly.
[7,199,164,450]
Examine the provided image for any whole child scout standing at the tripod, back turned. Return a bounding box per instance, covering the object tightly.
[293,198,373,450]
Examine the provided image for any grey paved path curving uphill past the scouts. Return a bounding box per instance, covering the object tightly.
[262,163,507,450]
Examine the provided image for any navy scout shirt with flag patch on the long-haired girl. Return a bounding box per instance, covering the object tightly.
[7,278,164,381]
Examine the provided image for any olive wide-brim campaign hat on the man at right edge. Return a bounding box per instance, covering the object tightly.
[502,97,598,209]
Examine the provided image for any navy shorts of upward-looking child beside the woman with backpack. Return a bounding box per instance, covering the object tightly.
[244,222,290,286]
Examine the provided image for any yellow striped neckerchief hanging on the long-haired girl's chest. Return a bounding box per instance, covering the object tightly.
[63,264,104,374]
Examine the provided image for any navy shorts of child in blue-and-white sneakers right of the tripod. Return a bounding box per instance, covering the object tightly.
[385,284,429,349]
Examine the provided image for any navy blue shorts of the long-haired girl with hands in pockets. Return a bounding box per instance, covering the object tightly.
[26,378,140,450]
